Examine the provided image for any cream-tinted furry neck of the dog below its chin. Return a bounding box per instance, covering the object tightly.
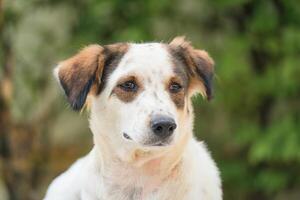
[94,130,192,193]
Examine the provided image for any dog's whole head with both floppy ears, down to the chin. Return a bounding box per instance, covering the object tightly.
[56,38,213,162]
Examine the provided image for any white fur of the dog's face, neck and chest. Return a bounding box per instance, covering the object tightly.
[45,43,222,200]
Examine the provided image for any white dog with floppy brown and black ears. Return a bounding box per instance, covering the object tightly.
[44,37,222,200]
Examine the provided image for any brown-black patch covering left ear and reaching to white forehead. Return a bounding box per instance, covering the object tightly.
[55,44,128,110]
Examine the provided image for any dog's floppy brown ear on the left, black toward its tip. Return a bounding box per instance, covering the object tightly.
[54,45,104,110]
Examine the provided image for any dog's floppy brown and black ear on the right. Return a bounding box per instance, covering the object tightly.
[170,37,214,100]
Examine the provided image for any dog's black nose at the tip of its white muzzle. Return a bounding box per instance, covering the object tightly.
[150,116,177,138]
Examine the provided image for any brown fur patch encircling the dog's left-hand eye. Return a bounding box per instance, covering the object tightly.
[112,76,143,103]
